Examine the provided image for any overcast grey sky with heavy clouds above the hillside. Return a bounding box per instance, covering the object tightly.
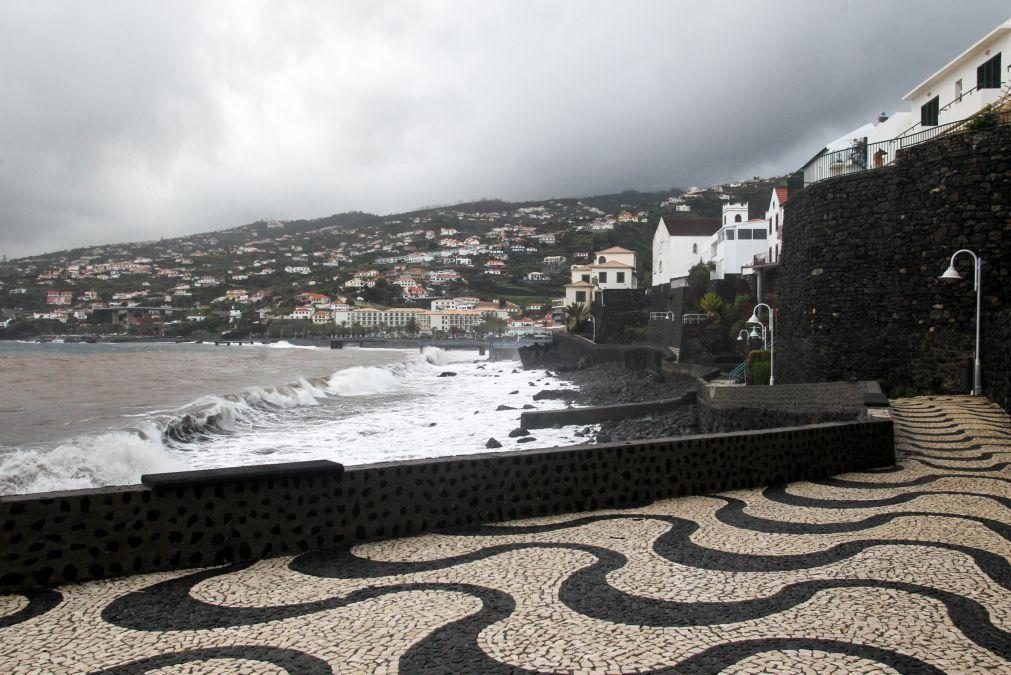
[0,0,1009,257]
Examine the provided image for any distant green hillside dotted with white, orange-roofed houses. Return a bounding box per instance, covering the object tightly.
[0,178,774,336]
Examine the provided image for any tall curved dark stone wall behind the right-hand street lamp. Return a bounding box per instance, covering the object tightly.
[775,126,1011,409]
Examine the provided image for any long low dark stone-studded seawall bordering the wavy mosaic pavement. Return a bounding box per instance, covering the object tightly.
[0,419,895,586]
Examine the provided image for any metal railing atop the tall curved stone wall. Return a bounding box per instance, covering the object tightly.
[804,104,1011,185]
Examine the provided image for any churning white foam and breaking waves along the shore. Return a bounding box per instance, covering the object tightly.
[0,348,579,494]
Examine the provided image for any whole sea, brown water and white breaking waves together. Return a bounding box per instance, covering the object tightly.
[0,343,578,494]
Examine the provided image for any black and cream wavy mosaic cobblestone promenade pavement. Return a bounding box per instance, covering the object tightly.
[0,397,1011,674]
